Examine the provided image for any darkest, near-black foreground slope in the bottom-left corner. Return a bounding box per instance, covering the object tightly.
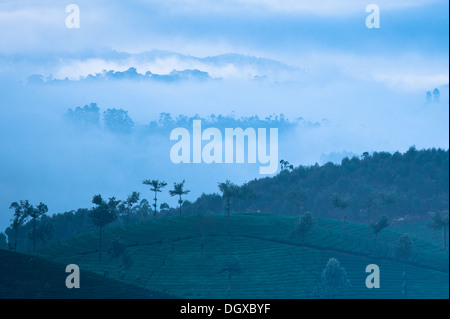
[0,250,179,299]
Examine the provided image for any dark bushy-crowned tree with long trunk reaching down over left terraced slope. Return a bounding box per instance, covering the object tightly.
[89,195,120,260]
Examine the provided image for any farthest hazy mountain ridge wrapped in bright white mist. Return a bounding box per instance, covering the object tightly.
[28,50,304,84]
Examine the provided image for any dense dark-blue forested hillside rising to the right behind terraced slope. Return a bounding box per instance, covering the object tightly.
[180,147,449,224]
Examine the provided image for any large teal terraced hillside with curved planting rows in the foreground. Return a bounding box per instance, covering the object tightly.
[35,215,449,298]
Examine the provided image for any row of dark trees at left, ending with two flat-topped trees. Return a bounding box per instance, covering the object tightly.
[0,179,190,258]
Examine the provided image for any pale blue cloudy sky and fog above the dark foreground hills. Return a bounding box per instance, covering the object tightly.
[0,0,449,231]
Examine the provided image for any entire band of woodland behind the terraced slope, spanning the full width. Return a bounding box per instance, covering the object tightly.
[0,147,449,254]
